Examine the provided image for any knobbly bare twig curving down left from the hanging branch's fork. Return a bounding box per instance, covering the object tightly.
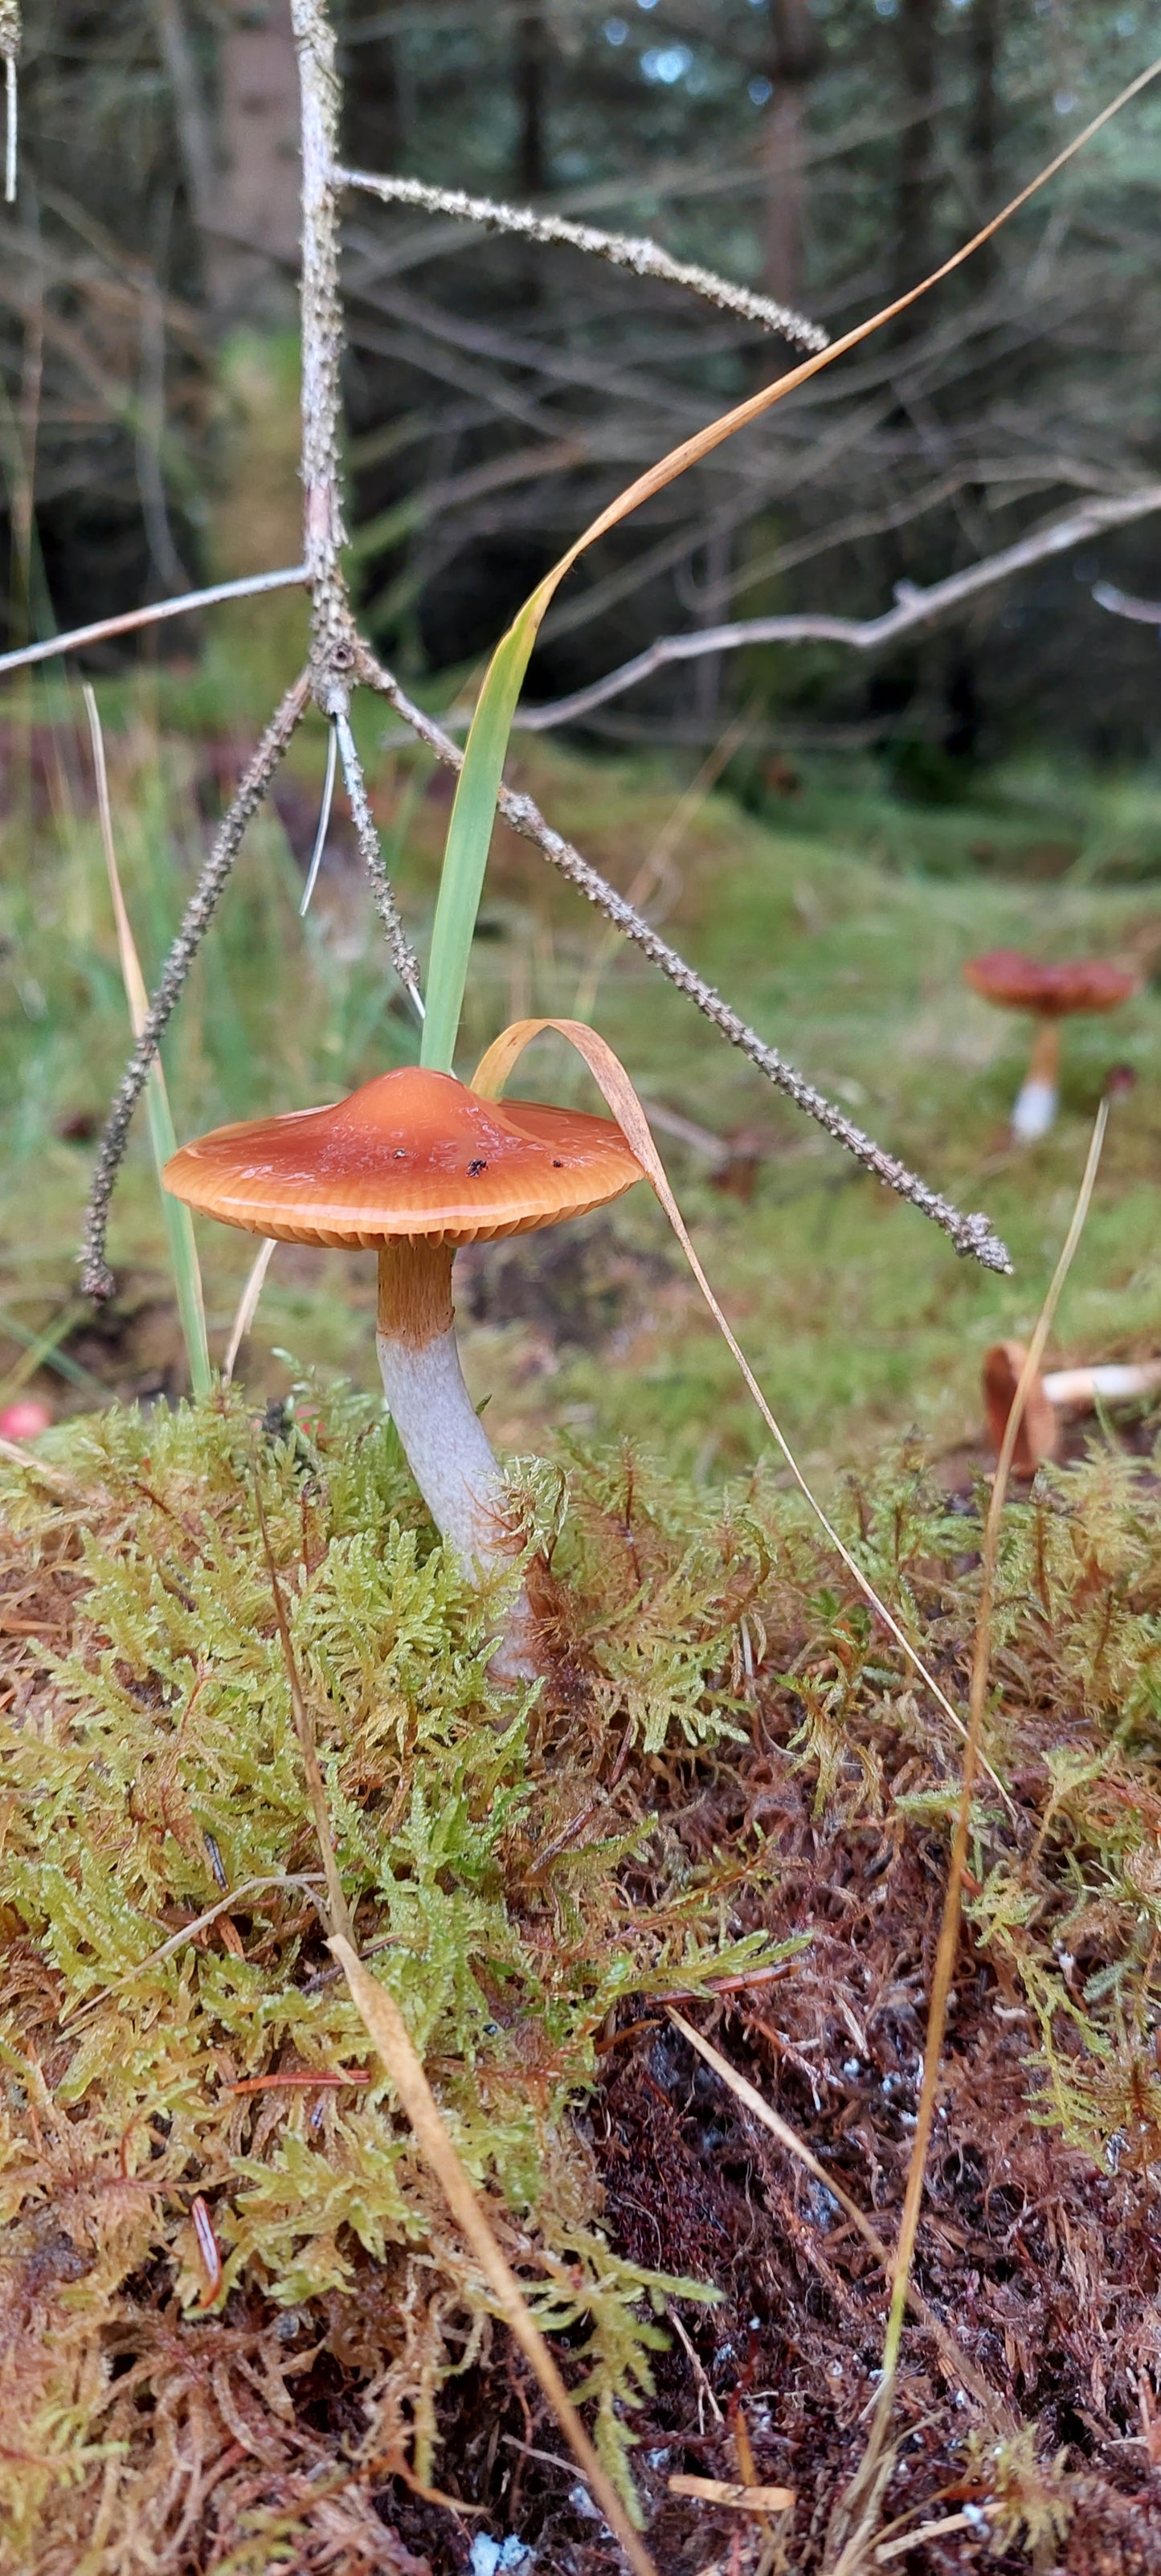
[80,673,312,1298]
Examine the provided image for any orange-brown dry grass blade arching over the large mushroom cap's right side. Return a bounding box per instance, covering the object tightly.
[471,1020,1014,1813]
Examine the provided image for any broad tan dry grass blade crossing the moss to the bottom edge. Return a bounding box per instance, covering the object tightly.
[329,1935,656,2576]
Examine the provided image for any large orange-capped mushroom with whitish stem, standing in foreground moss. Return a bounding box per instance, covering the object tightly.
[165,1066,644,1679]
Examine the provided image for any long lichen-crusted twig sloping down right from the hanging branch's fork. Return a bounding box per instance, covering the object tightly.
[358,644,1012,1273]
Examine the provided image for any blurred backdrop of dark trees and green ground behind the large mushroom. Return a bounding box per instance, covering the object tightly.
[0,0,1161,1474]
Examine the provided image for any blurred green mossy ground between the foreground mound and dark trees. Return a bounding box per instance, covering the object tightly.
[0,683,1161,1476]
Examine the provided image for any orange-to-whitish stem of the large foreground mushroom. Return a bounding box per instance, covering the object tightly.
[376,1239,541,1683]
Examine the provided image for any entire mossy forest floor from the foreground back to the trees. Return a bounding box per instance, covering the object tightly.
[0,688,1161,2576]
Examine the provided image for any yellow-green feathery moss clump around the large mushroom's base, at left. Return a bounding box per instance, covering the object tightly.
[2,1399,792,2566]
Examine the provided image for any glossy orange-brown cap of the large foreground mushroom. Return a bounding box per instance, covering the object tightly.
[165,1066,644,1247]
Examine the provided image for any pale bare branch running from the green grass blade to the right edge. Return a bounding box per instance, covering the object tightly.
[513,485,1161,734]
